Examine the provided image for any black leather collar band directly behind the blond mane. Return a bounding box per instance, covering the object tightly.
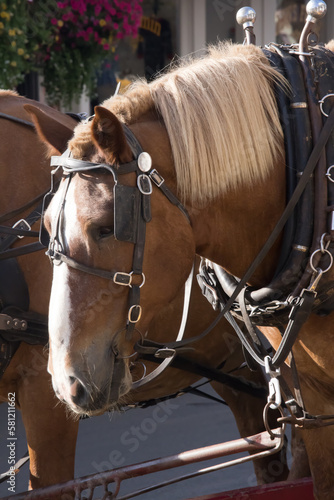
[262,44,314,292]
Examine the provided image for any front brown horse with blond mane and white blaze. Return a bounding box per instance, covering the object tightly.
[28,40,334,500]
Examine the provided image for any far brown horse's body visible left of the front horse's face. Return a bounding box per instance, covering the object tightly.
[0,91,78,488]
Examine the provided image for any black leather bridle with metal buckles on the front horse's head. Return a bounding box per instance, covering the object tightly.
[46,125,193,387]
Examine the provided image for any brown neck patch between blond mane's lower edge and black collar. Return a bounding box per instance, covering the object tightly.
[190,165,285,286]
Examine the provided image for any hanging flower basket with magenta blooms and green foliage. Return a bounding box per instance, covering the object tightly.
[0,0,142,106]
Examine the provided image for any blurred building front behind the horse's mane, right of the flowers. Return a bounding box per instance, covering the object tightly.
[31,0,334,113]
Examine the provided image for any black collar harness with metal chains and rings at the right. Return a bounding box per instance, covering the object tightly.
[198,22,334,428]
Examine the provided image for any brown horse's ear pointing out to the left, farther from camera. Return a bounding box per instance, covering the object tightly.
[24,104,77,154]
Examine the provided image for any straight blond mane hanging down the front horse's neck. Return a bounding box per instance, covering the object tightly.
[71,44,284,205]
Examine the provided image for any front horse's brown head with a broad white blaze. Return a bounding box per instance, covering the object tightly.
[30,107,195,414]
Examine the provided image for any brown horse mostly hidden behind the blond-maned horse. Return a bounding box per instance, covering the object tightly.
[0,91,288,489]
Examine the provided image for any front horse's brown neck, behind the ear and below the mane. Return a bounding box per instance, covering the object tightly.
[131,117,285,286]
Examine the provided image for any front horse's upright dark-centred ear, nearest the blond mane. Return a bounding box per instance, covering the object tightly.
[92,106,132,163]
